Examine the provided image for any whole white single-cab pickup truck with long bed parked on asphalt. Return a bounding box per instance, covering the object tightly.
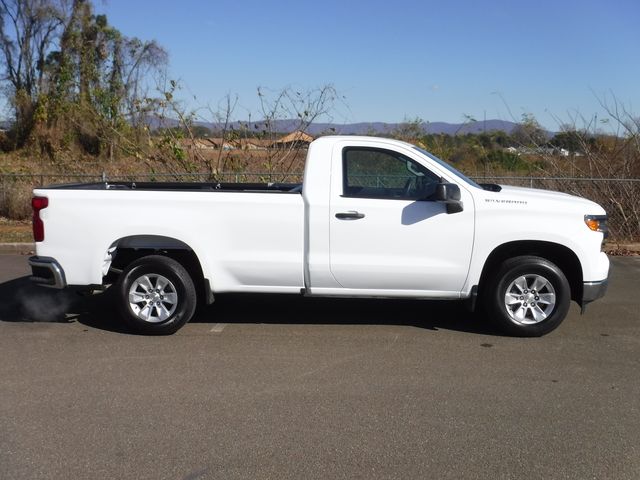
[29,136,609,336]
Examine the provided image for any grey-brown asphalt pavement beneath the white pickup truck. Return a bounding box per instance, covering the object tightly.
[0,255,640,480]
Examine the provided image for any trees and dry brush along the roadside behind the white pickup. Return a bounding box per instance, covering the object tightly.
[0,0,640,244]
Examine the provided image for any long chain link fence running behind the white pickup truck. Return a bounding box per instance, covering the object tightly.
[0,172,640,241]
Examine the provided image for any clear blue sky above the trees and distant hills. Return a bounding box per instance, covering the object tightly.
[96,0,640,129]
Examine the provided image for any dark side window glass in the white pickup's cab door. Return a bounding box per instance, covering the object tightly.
[342,147,440,200]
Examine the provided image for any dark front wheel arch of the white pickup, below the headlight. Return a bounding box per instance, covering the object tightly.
[479,240,583,302]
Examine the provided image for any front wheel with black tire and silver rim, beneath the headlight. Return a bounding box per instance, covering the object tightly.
[483,255,571,337]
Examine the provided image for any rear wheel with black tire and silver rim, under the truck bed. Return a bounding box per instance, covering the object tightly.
[115,255,197,335]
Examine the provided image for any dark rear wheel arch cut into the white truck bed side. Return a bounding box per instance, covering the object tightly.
[103,235,213,304]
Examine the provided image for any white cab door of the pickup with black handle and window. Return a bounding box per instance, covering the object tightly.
[329,147,474,297]
